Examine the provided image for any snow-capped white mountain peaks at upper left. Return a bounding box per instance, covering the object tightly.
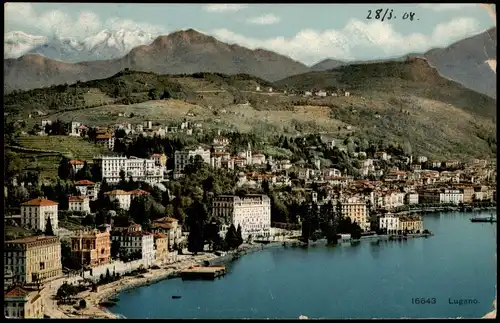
[4,29,157,62]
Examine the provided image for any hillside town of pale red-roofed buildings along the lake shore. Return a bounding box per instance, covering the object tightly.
[4,114,496,318]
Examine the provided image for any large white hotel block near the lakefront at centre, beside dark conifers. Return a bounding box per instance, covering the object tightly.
[212,194,271,240]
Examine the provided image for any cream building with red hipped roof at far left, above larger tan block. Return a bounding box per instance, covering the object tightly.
[21,198,59,234]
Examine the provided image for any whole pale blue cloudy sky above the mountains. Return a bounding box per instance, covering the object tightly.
[4,3,495,64]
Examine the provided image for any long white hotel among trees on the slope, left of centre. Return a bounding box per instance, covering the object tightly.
[94,156,164,183]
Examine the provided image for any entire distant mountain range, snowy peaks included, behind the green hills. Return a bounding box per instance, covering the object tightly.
[4,27,496,98]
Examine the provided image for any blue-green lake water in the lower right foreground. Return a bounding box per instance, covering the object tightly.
[110,212,497,318]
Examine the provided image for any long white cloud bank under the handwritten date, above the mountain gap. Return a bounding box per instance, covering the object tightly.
[211,18,483,64]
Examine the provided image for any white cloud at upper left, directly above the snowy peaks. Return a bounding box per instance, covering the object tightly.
[5,3,165,38]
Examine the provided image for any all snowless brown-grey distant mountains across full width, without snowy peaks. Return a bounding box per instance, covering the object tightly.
[4,27,496,98]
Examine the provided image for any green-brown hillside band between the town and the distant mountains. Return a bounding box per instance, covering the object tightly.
[4,58,496,158]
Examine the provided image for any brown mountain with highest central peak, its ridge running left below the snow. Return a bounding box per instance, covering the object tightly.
[4,29,308,91]
